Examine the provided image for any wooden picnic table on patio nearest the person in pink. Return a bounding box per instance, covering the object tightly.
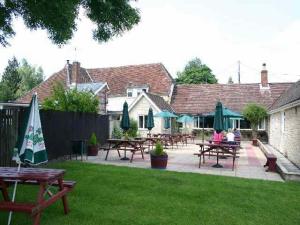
[194,143,239,170]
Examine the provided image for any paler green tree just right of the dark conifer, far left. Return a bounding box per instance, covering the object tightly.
[17,59,44,97]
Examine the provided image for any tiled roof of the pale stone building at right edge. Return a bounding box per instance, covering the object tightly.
[270,80,300,110]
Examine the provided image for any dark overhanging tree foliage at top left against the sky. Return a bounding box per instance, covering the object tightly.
[0,0,140,46]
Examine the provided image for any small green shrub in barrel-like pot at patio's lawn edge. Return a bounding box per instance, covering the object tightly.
[150,142,168,169]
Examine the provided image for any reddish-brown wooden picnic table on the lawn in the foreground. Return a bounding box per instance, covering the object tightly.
[0,167,76,225]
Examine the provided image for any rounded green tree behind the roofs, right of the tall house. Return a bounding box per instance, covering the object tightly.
[176,58,218,84]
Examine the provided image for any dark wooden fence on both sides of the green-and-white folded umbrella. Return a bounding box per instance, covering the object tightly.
[0,109,109,166]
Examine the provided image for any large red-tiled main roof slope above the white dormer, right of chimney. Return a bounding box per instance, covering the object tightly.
[88,63,174,97]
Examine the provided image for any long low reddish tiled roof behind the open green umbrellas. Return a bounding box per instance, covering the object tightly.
[171,83,292,114]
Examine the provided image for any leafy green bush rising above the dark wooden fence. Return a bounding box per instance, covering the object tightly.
[42,83,99,113]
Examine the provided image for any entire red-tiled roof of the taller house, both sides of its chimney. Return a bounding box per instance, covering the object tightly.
[17,63,174,103]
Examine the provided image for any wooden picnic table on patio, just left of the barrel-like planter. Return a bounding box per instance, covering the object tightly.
[104,139,146,162]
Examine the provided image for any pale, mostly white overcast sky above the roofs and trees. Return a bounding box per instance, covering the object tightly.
[0,0,300,83]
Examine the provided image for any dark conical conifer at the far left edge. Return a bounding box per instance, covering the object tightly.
[0,57,22,102]
